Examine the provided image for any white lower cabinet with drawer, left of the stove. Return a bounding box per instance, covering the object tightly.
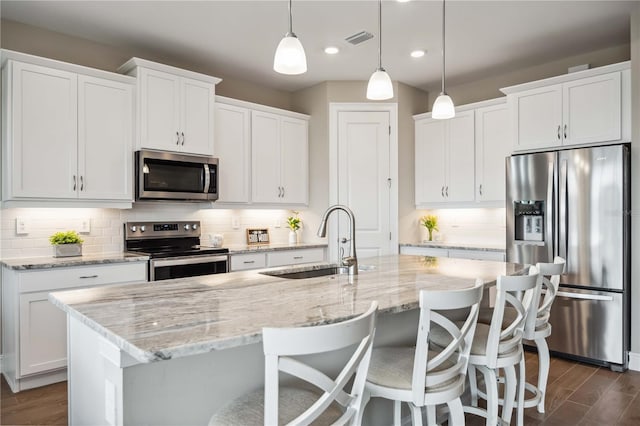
[2,261,147,392]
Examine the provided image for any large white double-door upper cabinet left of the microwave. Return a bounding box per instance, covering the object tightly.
[2,51,135,207]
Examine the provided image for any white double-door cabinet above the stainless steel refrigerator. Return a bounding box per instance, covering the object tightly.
[502,62,631,151]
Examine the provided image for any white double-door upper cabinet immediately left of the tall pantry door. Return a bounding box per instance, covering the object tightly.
[251,111,309,205]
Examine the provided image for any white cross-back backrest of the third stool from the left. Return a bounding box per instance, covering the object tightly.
[486,272,542,368]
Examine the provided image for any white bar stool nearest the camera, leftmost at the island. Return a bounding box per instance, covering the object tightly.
[209,302,378,426]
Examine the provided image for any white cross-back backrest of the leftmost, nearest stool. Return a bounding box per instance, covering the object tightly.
[262,302,378,425]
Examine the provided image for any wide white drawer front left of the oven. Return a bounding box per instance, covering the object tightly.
[19,262,147,293]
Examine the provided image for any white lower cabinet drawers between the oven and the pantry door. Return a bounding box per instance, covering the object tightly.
[230,247,326,272]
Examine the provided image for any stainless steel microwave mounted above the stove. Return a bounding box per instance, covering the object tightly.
[135,150,218,201]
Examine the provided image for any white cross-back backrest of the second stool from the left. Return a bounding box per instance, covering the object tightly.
[411,280,484,406]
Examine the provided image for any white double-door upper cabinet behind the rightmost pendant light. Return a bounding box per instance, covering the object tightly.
[415,110,475,206]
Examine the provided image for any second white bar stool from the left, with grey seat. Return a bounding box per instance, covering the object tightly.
[363,280,483,425]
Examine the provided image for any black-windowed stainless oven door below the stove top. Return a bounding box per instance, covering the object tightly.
[149,254,229,281]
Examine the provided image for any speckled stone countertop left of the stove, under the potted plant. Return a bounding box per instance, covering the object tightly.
[0,252,149,270]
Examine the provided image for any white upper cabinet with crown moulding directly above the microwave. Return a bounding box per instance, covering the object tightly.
[118,58,221,155]
